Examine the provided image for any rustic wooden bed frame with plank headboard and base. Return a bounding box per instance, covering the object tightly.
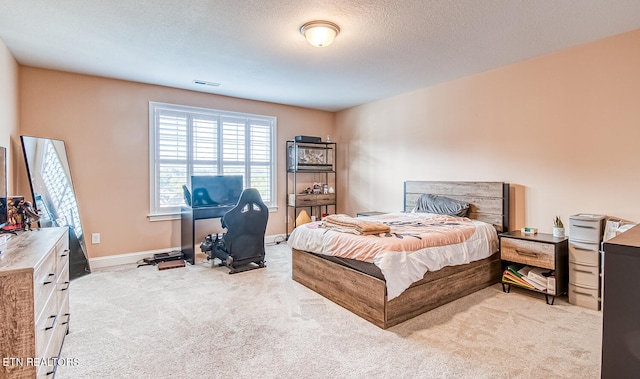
[291,181,509,329]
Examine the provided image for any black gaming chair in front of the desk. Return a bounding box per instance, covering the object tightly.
[210,188,269,274]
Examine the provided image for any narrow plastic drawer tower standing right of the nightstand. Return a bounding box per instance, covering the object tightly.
[569,213,605,310]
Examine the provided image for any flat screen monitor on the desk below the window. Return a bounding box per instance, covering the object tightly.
[191,175,243,208]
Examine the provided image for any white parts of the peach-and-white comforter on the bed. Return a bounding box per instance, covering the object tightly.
[288,213,498,300]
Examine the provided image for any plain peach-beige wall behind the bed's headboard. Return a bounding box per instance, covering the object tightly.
[336,30,640,232]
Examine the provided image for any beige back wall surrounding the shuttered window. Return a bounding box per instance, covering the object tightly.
[16,66,335,258]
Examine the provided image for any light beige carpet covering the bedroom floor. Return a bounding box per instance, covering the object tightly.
[56,244,602,379]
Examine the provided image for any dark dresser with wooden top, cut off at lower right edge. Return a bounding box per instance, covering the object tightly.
[601,225,640,378]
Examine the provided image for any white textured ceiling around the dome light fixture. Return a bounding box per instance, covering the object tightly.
[0,0,640,111]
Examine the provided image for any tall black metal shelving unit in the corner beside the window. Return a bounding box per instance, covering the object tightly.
[285,141,336,238]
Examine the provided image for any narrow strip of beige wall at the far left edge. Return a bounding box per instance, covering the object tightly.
[0,40,22,195]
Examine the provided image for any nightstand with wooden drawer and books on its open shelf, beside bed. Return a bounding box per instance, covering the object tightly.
[500,230,568,305]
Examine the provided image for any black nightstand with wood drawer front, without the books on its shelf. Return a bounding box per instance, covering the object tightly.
[499,231,569,305]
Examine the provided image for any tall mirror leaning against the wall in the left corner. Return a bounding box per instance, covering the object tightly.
[20,136,91,279]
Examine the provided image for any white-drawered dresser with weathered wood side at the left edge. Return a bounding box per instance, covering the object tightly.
[0,228,69,379]
